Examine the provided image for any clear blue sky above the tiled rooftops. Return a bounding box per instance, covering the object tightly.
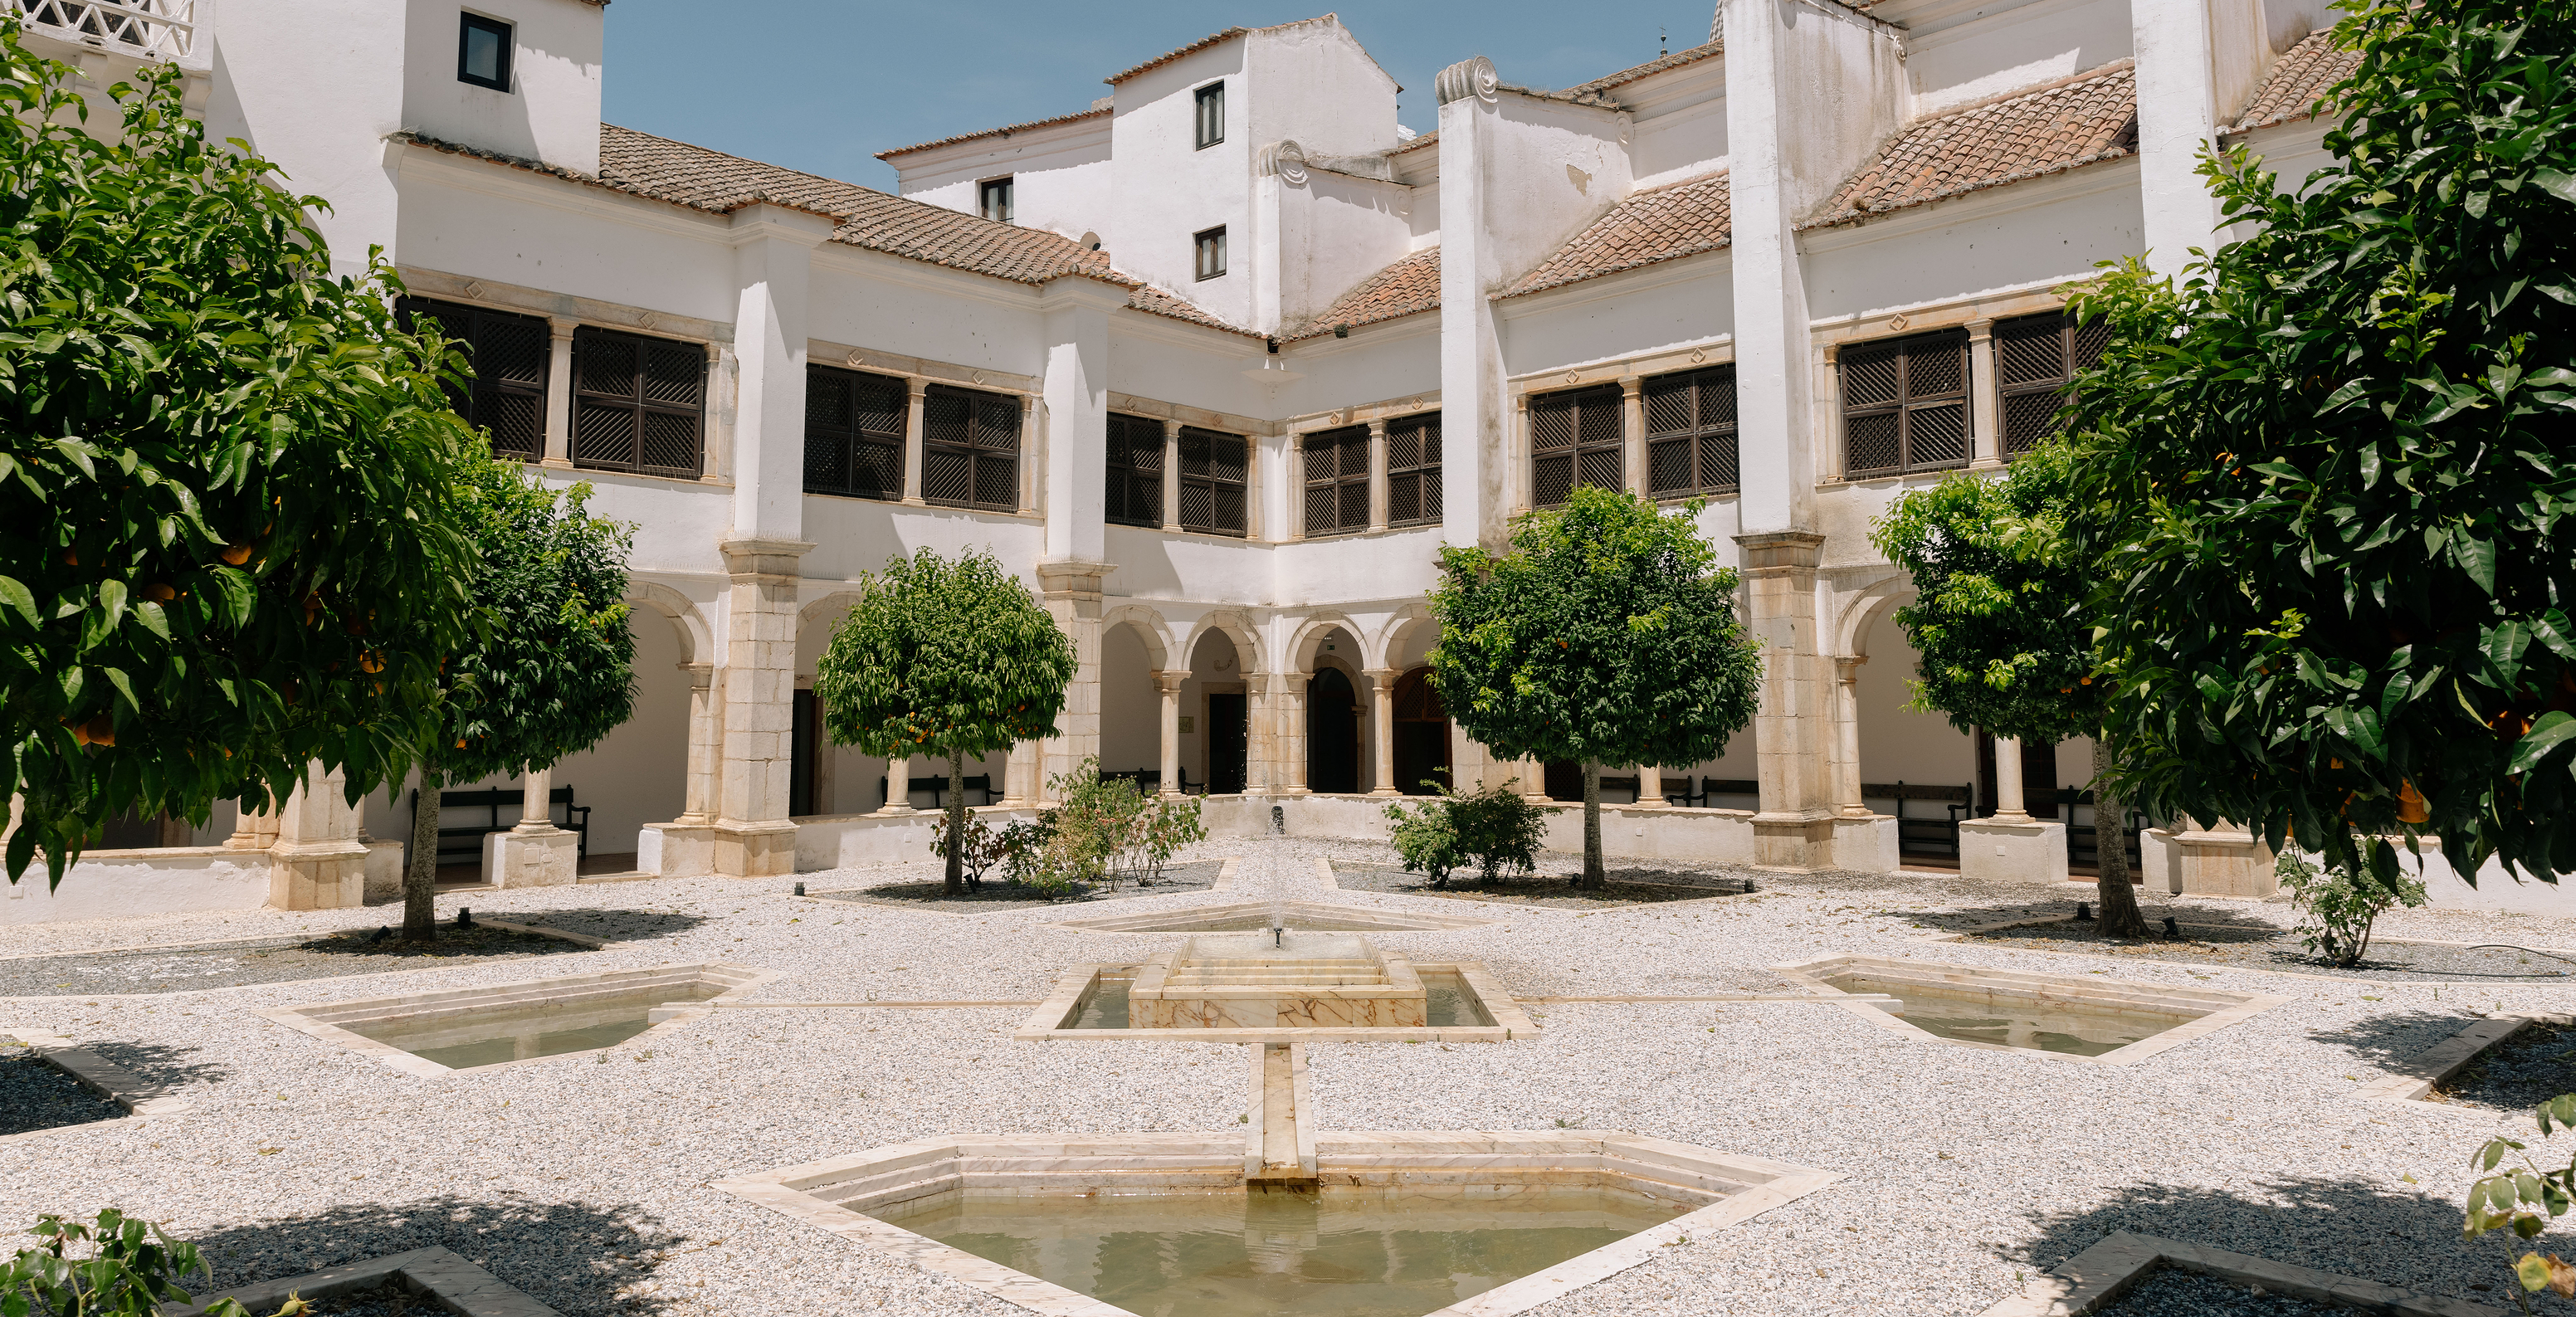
[605,0,1715,191]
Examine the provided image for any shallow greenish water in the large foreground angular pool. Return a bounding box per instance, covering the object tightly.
[873,1186,1692,1317]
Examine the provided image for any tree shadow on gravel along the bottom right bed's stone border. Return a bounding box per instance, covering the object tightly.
[1999,1180,2576,1315]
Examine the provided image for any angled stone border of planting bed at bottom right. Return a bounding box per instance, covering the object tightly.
[1978,1229,2504,1317]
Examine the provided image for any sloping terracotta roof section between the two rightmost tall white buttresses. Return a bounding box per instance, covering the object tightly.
[1798,59,2138,229]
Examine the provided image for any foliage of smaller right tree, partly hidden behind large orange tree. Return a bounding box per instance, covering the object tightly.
[1871,443,2102,742]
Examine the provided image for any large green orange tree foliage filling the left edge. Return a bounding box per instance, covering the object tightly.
[0,21,474,881]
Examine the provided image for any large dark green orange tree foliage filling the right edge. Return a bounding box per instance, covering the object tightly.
[2074,0,2576,886]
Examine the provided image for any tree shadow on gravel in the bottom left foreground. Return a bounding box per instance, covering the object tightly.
[193,1191,705,1317]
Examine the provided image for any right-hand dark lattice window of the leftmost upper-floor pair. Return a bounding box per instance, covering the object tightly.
[572,324,705,480]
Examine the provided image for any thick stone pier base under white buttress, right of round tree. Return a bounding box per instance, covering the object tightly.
[1736,531,1834,869]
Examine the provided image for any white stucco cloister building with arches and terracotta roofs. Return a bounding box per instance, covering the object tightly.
[25,0,2472,917]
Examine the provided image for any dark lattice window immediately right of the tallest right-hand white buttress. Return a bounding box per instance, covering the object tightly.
[1842,330,1968,480]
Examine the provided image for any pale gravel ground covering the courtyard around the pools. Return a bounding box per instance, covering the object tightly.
[0,837,2576,1317]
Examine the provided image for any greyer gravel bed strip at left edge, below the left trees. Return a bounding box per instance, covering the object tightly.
[0,925,590,998]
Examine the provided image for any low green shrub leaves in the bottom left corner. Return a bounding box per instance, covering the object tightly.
[0,1206,309,1317]
